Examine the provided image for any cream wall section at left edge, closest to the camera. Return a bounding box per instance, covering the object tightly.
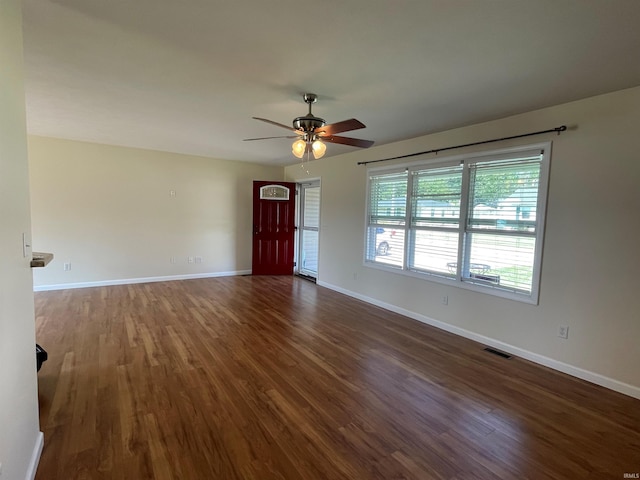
[0,0,42,480]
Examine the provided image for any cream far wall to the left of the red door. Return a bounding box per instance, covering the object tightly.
[29,137,283,290]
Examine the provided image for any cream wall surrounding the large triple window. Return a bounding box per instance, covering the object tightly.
[285,87,640,398]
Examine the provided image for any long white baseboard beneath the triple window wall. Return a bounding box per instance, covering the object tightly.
[317,281,640,399]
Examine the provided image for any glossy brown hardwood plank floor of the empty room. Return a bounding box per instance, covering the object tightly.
[35,276,640,480]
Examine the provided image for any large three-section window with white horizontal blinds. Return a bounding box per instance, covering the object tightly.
[365,144,550,303]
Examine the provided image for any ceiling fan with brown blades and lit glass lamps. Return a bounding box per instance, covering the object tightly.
[245,93,374,158]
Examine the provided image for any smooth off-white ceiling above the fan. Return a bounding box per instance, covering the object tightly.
[23,0,640,165]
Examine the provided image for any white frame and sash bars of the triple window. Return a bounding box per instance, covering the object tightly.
[363,142,552,305]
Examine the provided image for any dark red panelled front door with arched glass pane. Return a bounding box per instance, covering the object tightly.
[252,181,296,275]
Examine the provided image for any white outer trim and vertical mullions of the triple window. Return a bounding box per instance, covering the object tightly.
[363,141,552,305]
